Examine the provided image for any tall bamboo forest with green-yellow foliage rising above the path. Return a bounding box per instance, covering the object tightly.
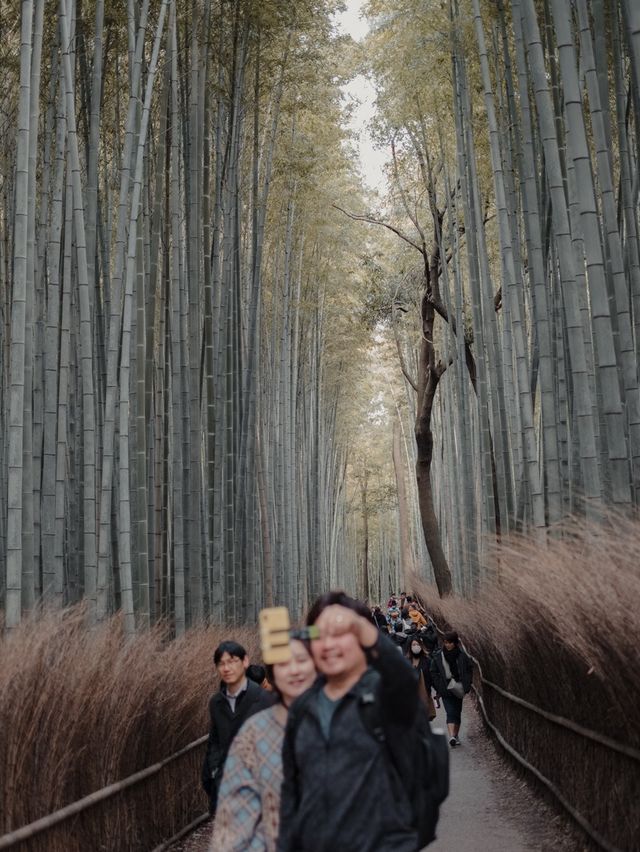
[0,0,640,636]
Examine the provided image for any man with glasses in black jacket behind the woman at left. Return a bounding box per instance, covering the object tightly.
[202,640,273,814]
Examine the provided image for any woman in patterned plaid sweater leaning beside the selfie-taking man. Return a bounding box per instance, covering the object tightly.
[210,639,316,852]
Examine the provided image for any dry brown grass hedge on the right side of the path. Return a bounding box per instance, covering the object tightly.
[415,518,640,852]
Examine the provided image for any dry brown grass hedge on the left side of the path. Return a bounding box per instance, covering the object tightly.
[0,608,257,852]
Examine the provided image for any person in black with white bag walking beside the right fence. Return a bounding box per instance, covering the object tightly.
[431,630,473,748]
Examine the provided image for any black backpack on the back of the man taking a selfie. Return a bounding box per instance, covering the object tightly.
[360,693,449,849]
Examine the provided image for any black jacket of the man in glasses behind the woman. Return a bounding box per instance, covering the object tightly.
[202,680,275,813]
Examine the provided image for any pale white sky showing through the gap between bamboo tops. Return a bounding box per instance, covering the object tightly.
[335,0,389,192]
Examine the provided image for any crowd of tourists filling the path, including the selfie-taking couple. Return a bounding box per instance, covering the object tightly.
[202,592,472,852]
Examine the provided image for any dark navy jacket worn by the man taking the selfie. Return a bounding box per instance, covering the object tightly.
[277,635,418,852]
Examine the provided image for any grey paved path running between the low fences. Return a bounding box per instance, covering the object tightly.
[171,700,585,852]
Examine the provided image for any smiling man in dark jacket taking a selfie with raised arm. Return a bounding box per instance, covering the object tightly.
[277,592,418,852]
